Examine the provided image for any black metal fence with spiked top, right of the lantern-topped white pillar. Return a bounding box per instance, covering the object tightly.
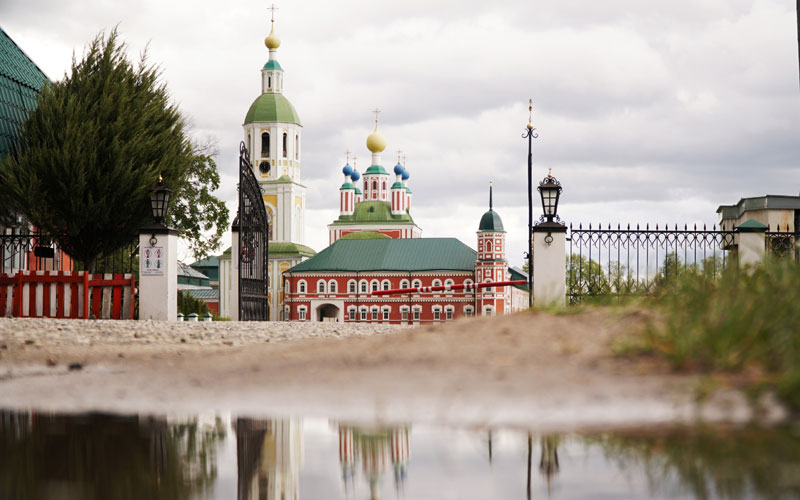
[567,224,736,304]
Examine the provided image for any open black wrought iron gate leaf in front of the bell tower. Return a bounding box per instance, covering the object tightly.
[236,142,269,321]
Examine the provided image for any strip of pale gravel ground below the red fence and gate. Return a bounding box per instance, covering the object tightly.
[0,318,407,350]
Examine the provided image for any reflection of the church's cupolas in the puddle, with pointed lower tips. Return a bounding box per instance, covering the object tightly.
[339,425,410,500]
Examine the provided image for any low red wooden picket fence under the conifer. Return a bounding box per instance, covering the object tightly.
[0,271,136,319]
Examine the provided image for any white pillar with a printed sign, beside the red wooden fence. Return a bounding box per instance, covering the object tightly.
[139,224,178,321]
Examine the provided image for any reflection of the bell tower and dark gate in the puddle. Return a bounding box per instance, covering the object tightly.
[236,418,303,500]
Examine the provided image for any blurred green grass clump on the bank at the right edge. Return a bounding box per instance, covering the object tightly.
[617,259,800,410]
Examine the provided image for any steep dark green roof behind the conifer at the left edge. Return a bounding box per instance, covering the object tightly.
[0,28,48,159]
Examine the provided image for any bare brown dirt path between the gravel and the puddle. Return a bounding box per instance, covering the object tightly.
[0,311,778,430]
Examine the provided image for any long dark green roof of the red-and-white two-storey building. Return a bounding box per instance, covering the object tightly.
[288,238,477,273]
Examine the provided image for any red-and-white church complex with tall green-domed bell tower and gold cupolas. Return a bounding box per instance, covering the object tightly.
[220,14,528,325]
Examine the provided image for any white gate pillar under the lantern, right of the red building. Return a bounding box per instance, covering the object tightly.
[531,222,567,308]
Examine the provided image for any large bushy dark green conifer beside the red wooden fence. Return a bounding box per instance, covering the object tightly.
[0,28,209,270]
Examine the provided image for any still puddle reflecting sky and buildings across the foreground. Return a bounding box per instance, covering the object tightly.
[0,411,800,500]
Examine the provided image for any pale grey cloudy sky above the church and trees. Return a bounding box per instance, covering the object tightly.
[0,0,800,265]
